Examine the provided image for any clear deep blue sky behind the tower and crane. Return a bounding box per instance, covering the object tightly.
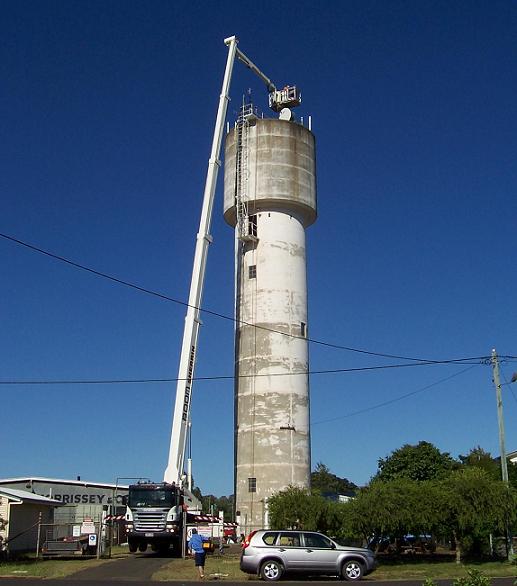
[0,0,517,495]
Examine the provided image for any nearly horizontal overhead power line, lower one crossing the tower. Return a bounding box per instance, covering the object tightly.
[0,360,484,386]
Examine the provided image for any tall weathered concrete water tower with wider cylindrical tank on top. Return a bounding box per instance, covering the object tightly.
[224,87,317,532]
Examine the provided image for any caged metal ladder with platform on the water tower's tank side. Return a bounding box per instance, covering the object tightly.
[235,104,258,242]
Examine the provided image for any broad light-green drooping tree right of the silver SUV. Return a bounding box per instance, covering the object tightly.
[343,458,517,561]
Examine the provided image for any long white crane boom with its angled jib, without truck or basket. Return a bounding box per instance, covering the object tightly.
[164,36,276,489]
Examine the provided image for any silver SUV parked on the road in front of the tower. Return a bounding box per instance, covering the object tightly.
[240,529,377,581]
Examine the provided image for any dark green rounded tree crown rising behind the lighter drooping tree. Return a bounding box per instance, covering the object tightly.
[375,441,459,480]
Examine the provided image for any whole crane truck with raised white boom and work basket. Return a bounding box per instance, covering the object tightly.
[126,36,301,553]
